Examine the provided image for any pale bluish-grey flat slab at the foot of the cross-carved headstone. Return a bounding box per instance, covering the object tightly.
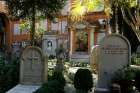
[6,84,41,93]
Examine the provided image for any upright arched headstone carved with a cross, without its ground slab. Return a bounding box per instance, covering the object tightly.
[20,46,47,85]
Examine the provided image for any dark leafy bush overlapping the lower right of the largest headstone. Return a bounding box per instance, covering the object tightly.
[112,67,135,93]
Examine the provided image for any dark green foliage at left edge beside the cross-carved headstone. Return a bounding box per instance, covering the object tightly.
[0,59,19,93]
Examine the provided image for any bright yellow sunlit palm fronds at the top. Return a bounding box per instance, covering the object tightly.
[70,0,100,21]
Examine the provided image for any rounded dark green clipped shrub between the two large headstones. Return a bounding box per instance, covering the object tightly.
[74,69,93,93]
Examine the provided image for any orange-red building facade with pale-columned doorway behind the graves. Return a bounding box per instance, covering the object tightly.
[0,0,108,61]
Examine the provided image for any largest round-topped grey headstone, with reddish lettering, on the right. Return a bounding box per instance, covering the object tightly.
[97,34,131,93]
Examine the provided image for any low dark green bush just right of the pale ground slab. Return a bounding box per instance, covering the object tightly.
[34,72,66,93]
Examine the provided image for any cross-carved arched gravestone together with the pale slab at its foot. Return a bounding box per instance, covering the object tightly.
[6,46,47,93]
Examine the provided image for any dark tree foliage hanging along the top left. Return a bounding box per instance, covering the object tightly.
[7,0,66,18]
